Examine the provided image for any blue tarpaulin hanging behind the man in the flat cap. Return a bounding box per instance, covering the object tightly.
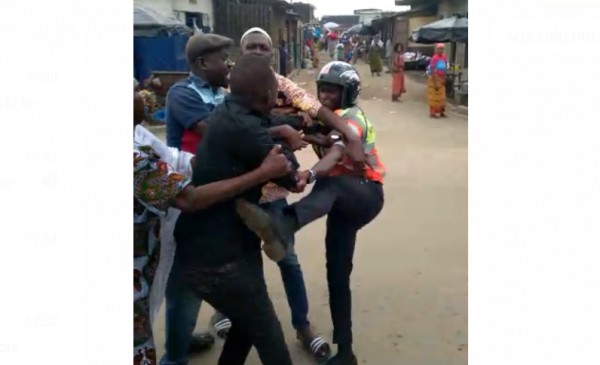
[133,35,189,81]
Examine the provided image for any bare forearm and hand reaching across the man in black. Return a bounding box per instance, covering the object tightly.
[173,145,292,212]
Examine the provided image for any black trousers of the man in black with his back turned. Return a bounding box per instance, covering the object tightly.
[184,251,292,365]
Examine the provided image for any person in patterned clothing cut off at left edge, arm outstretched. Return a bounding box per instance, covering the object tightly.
[133,91,291,365]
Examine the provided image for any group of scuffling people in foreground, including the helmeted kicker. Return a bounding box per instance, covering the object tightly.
[134,28,386,365]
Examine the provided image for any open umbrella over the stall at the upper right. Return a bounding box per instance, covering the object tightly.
[410,15,469,44]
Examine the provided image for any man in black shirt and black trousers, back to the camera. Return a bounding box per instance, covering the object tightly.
[175,54,296,365]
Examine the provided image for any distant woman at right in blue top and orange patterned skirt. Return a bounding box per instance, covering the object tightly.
[427,43,448,118]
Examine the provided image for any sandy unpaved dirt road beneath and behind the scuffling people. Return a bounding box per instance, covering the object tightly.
[150,58,468,365]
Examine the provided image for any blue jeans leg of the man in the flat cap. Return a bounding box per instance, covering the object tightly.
[160,262,202,365]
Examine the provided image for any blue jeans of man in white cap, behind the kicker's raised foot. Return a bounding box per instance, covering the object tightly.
[262,199,310,330]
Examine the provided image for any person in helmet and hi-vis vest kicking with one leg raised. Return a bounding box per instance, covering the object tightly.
[237,62,385,365]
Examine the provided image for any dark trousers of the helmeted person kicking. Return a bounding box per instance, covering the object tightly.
[287,176,384,344]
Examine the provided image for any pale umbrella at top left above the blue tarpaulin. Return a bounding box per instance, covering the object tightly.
[133,5,194,37]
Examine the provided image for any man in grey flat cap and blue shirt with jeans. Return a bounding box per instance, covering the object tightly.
[161,34,233,365]
